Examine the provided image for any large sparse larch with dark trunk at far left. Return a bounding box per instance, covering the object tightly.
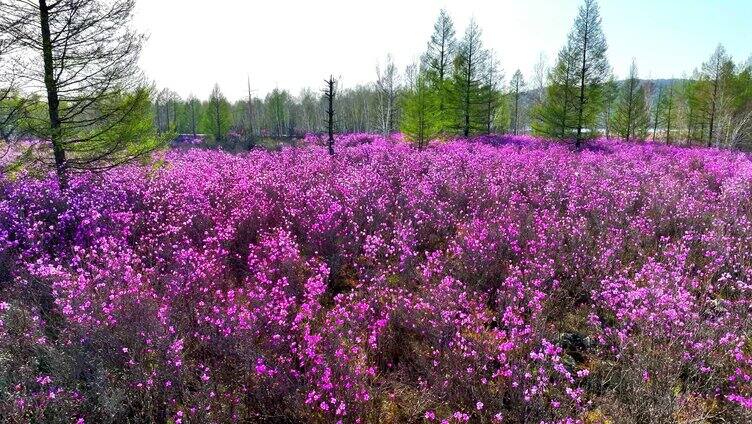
[0,0,161,189]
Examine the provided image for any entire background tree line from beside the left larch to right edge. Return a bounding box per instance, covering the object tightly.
[147,0,752,152]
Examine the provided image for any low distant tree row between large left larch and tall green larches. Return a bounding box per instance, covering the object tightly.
[152,56,403,148]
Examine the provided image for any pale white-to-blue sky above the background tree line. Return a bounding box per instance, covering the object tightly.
[136,0,752,99]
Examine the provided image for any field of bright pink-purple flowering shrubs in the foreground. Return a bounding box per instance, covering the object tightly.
[0,135,752,424]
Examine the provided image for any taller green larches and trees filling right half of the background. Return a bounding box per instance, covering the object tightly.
[401,0,752,147]
